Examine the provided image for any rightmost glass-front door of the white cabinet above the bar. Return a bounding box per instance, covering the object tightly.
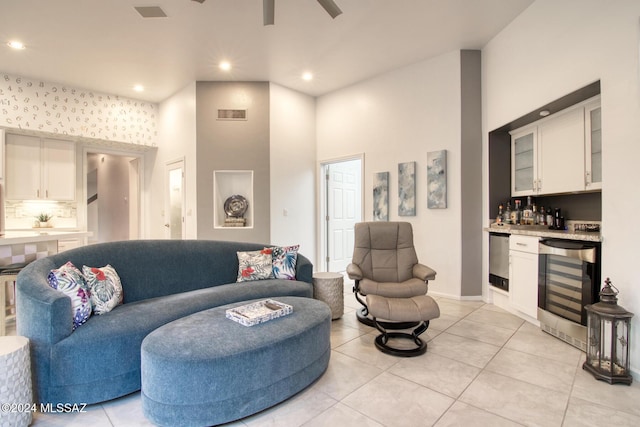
[584,97,602,190]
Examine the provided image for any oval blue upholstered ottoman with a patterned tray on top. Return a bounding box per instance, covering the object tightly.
[141,298,331,426]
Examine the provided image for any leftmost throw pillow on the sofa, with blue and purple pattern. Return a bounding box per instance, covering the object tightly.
[47,261,91,331]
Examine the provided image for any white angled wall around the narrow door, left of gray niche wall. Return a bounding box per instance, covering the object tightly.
[153,82,197,239]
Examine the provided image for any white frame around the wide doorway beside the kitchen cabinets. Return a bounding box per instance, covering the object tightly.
[78,145,147,239]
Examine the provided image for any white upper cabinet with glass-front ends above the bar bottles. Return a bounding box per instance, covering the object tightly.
[511,97,602,197]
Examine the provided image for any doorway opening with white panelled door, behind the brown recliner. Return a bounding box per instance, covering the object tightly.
[320,156,363,274]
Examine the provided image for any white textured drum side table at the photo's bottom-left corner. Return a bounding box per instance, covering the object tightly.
[0,336,32,427]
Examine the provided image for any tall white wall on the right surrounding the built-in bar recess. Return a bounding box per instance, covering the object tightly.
[482,0,640,373]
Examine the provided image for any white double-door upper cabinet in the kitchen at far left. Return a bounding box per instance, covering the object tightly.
[5,134,76,201]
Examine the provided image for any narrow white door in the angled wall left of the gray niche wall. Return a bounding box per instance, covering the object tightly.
[164,160,186,240]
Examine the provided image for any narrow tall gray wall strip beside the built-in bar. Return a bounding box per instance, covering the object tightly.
[460,50,483,297]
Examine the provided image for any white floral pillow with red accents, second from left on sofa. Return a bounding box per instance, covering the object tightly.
[82,264,122,314]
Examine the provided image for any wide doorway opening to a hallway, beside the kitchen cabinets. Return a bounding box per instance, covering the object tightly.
[86,152,142,243]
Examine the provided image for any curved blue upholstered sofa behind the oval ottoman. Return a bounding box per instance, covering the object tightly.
[16,240,313,404]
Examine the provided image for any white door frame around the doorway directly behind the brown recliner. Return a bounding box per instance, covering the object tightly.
[316,153,365,271]
